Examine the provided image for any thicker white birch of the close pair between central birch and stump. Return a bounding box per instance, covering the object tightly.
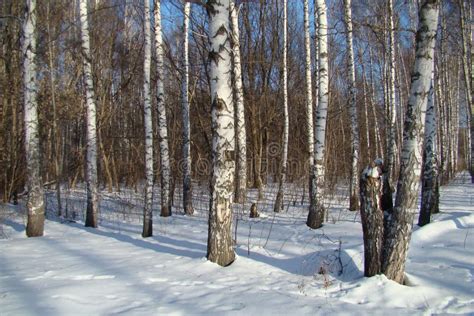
[306,0,329,228]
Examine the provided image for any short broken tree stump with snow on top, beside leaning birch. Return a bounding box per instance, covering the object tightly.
[360,164,384,277]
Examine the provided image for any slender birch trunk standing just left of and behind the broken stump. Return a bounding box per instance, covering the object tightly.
[344,0,362,211]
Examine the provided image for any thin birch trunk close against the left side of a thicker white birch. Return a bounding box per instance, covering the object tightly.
[303,0,320,228]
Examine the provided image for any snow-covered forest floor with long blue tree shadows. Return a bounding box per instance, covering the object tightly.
[0,174,474,315]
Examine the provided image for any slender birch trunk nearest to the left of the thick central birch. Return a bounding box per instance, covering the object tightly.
[181,2,194,215]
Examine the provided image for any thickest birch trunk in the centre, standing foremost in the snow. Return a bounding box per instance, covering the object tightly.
[206,0,235,266]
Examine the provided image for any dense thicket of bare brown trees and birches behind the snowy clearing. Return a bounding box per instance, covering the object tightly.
[0,0,474,276]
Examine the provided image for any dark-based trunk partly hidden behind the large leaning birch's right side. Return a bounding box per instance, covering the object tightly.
[418,80,439,226]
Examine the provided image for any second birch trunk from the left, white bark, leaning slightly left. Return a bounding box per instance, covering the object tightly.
[79,0,99,227]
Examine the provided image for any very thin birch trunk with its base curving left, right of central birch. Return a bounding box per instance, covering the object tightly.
[273,0,290,212]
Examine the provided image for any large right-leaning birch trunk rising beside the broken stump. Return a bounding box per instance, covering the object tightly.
[382,0,439,283]
